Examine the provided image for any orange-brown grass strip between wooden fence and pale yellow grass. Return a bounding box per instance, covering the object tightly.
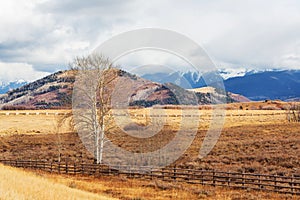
[19,169,297,200]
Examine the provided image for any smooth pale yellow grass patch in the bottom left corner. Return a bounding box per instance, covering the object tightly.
[0,165,113,200]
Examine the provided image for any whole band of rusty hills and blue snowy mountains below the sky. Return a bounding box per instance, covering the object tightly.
[0,70,300,109]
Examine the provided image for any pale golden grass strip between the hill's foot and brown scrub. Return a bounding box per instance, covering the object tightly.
[0,109,286,135]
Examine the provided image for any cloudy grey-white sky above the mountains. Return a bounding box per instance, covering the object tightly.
[0,0,300,82]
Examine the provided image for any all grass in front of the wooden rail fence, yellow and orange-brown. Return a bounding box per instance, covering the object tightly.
[0,165,297,200]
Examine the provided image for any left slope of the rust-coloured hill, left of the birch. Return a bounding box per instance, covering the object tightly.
[0,71,75,109]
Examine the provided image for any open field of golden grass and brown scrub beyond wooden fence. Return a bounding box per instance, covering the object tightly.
[0,110,300,175]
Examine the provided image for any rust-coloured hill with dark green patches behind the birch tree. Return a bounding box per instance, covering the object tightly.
[0,69,239,109]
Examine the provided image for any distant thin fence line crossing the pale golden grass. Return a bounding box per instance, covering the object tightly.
[0,112,287,118]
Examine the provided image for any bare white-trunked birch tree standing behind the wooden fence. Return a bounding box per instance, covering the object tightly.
[71,54,118,164]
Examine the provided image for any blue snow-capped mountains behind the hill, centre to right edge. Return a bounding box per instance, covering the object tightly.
[142,70,300,101]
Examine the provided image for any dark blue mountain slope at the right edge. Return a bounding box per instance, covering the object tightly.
[224,70,300,101]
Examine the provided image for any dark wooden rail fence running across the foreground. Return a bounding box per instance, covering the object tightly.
[0,160,300,195]
